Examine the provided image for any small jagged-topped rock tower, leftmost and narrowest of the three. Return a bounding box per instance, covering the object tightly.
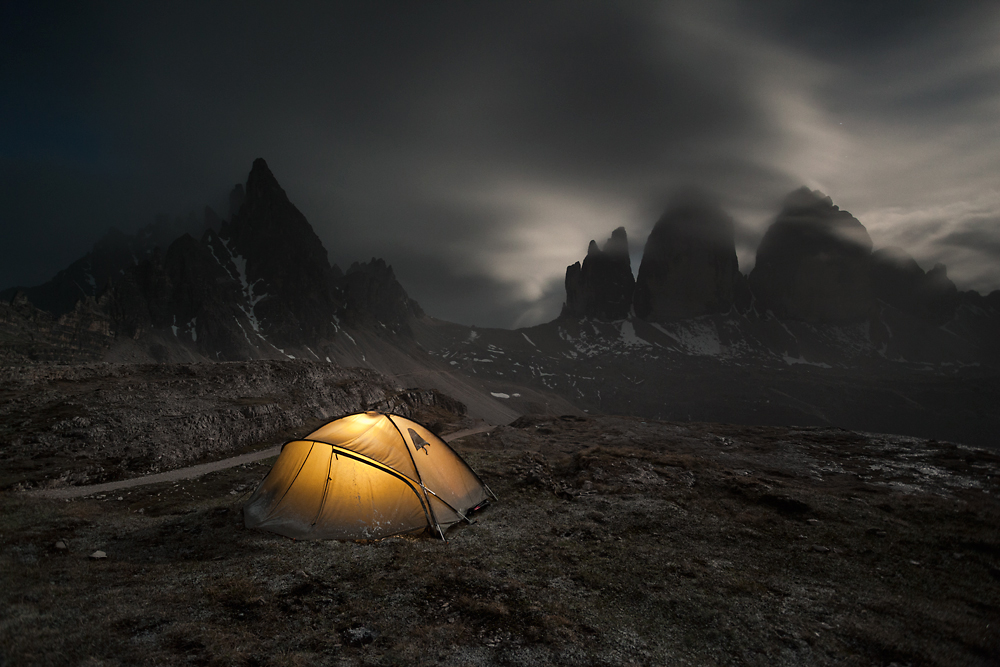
[562,227,635,320]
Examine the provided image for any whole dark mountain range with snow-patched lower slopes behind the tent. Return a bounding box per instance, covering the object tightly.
[0,159,1000,441]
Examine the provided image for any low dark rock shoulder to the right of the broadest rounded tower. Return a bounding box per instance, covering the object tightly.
[871,247,961,324]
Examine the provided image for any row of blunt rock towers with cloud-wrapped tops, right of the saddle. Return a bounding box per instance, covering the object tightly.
[562,187,1000,326]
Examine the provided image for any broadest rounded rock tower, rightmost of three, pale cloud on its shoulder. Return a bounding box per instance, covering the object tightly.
[750,188,874,324]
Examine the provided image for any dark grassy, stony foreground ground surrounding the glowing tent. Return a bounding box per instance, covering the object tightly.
[0,371,1000,666]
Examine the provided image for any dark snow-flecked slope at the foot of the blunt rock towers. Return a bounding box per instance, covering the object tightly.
[413,316,1000,448]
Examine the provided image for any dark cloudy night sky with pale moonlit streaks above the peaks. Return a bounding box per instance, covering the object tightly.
[0,0,1000,326]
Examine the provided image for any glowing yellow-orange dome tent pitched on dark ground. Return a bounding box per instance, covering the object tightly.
[243,412,492,540]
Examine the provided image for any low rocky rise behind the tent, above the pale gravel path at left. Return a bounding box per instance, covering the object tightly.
[0,361,461,489]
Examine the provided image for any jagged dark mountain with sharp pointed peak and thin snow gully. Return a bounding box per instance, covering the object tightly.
[0,159,423,361]
